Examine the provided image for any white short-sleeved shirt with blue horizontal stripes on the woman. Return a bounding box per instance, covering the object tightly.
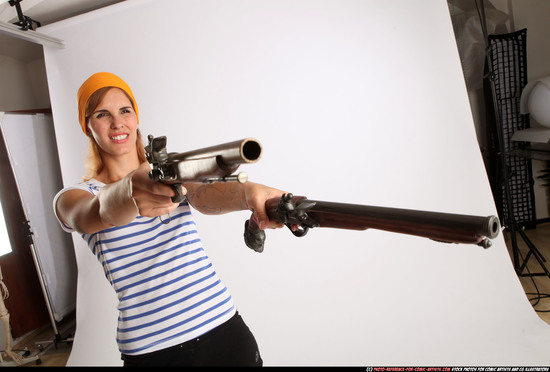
[54,180,236,355]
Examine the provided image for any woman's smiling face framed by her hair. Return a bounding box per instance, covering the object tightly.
[88,88,138,156]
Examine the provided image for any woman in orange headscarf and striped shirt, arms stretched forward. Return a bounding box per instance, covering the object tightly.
[54,72,283,366]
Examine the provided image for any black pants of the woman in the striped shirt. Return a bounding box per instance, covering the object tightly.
[122,313,263,367]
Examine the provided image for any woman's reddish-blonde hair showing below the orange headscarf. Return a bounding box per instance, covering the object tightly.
[83,86,147,181]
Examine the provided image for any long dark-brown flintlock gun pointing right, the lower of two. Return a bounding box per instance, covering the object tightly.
[244,194,500,252]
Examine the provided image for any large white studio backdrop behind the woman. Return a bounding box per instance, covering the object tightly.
[40,0,550,365]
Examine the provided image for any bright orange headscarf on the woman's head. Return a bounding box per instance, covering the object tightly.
[77,72,139,135]
